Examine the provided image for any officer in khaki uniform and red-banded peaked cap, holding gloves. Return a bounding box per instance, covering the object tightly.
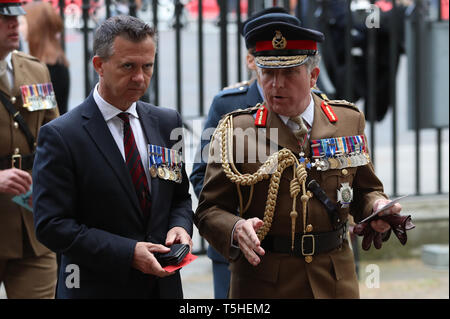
[195,13,401,298]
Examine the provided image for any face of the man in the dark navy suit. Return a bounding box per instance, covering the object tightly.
[93,36,156,111]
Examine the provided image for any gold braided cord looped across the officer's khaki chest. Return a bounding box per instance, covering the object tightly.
[217,114,311,250]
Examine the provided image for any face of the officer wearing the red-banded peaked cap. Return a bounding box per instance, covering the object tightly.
[258,65,319,117]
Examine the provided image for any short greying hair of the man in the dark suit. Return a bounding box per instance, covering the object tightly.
[94,15,156,60]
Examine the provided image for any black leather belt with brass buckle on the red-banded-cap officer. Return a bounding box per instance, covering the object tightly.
[261,223,347,256]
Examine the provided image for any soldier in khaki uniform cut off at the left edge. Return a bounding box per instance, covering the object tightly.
[0,0,59,299]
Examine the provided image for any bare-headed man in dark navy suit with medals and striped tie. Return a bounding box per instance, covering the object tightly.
[33,16,193,298]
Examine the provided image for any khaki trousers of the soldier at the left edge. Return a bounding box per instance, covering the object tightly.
[0,251,56,299]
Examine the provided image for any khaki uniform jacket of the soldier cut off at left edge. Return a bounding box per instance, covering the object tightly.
[0,51,59,259]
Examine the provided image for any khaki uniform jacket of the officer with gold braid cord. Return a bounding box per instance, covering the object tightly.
[194,94,386,298]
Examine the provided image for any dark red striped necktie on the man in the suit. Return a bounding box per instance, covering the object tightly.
[117,113,151,218]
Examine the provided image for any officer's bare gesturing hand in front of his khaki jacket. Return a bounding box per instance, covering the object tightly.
[233,217,265,266]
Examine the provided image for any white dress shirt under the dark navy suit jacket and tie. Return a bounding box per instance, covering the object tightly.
[94,84,151,189]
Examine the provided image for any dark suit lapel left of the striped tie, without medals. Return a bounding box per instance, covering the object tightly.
[82,93,142,219]
